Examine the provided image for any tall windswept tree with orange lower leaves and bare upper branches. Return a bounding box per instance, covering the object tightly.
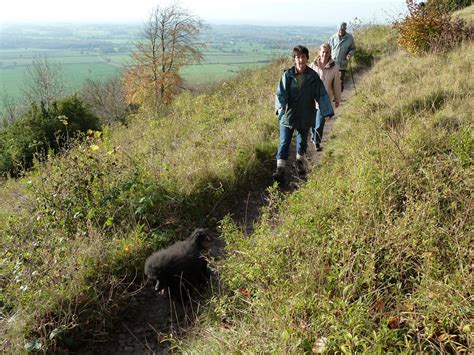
[124,4,203,111]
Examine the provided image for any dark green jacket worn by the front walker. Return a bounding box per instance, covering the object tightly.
[275,66,334,129]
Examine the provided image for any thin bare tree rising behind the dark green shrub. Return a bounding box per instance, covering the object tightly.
[23,57,66,107]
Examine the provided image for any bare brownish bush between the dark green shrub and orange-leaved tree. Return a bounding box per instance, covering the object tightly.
[81,77,129,124]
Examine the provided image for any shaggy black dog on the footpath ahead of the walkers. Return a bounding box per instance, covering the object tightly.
[145,228,209,296]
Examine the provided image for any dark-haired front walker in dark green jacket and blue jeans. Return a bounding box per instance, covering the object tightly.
[273,46,334,182]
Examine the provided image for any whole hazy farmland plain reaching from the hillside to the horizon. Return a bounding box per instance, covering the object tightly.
[0,24,332,101]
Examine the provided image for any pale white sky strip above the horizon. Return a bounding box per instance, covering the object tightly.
[0,0,405,26]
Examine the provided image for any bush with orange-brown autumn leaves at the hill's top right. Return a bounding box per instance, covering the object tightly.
[393,0,473,55]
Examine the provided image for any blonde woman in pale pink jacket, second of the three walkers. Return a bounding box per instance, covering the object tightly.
[309,43,341,151]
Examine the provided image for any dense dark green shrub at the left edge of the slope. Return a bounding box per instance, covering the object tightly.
[0,96,100,176]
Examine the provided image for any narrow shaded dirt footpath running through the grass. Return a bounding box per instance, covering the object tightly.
[74,83,353,355]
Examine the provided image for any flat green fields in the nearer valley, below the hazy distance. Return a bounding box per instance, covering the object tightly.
[0,43,286,100]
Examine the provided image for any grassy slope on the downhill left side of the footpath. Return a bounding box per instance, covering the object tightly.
[0,62,285,353]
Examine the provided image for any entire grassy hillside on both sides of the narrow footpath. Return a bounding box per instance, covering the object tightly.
[0,18,473,353]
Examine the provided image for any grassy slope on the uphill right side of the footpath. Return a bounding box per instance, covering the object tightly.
[181,44,474,354]
